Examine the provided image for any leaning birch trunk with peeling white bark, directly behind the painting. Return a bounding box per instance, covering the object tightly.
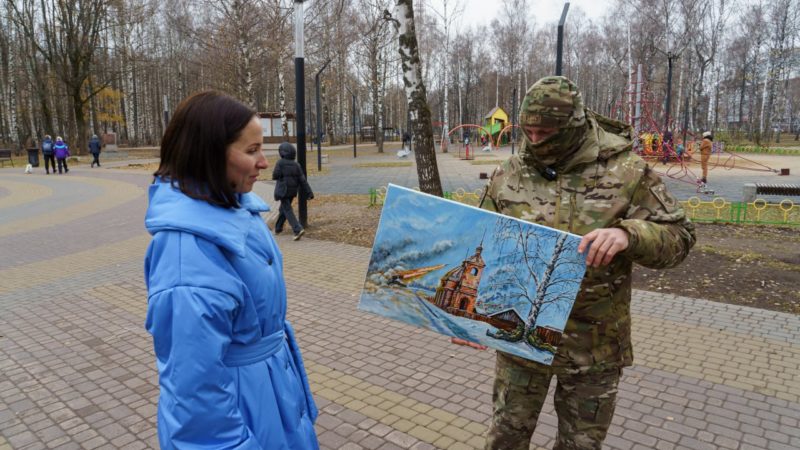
[394,0,442,197]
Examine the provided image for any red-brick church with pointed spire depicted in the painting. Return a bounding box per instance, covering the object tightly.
[432,242,486,321]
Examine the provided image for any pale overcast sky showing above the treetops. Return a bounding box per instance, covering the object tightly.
[429,0,614,26]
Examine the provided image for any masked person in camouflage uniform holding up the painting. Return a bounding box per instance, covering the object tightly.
[481,77,695,450]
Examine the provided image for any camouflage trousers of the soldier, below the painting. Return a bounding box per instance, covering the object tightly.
[486,352,622,450]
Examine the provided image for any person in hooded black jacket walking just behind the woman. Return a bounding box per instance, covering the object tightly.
[272,142,314,241]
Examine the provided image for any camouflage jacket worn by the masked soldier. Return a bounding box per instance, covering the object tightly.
[481,110,695,371]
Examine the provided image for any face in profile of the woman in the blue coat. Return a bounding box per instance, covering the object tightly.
[226,116,269,194]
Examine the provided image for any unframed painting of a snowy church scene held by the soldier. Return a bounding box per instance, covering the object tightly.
[358,185,586,365]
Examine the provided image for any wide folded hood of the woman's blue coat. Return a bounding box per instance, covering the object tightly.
[144,180,269,256]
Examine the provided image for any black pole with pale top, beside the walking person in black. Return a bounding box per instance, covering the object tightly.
[294,0,308,227]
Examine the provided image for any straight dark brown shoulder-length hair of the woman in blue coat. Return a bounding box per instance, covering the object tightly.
[153,91,256,208]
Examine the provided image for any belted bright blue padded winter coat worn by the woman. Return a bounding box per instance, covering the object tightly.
[145,181,319,450]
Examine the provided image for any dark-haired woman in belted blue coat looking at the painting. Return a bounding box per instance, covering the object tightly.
[145,92,319,450]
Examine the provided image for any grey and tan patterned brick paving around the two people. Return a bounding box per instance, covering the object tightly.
[0,155,800,450]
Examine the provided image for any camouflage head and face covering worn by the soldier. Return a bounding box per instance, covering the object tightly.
[519,76,586,166]
